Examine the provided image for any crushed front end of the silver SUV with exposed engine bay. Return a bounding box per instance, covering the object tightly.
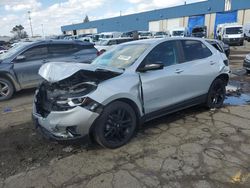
[33,62,121,140]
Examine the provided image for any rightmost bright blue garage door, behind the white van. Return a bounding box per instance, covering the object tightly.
[214,11,238,37]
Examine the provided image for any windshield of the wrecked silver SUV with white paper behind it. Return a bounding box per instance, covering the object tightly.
[92,44,149,69]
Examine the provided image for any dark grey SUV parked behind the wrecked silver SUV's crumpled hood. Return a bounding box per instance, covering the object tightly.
[0,40,97,101]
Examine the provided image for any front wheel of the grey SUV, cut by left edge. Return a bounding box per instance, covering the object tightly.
[0,78,14,101]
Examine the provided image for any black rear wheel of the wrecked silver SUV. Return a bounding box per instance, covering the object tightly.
[206,79,226,109]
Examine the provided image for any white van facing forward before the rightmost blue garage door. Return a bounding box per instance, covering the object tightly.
[220,23,244,46]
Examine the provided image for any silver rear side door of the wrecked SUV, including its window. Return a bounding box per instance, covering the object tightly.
[180,39,220,99]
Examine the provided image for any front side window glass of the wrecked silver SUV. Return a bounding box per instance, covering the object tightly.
[143,41,178,66]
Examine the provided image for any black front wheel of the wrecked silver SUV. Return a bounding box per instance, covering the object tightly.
[94,101,136,149]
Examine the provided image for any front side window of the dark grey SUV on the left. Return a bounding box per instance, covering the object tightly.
[21,45,48,61]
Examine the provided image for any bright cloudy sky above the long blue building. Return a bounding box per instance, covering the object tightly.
[0,0,204,36]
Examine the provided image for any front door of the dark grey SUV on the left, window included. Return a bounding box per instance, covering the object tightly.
[13,44,48,88]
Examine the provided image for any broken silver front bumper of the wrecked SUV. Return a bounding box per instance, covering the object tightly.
[32,100,99,140]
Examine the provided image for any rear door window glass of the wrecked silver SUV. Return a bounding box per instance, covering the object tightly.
[181,40,212,61]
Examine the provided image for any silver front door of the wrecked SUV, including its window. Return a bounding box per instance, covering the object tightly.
[139,41,187,114]
